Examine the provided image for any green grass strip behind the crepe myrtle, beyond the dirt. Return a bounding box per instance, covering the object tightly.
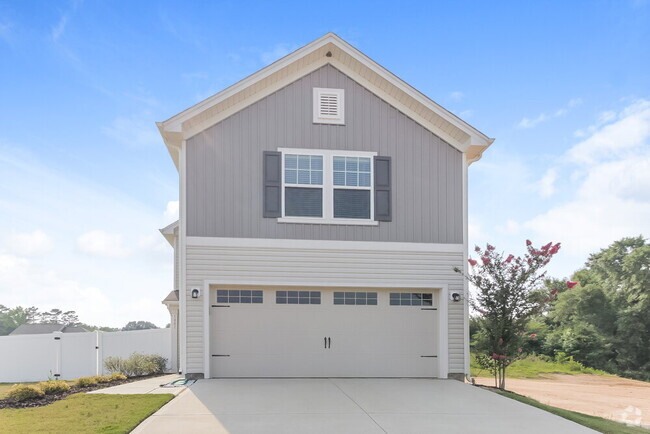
[470,355,612,378]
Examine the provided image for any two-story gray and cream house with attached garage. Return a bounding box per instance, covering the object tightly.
[158,33,493,378]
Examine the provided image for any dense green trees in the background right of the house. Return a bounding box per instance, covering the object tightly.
[470,236,650,381]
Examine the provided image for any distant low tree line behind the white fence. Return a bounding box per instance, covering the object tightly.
[0,304,158,336]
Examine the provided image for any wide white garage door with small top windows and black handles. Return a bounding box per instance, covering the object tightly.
[209,289,438,377]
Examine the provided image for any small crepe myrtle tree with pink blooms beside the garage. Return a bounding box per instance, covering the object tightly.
[454,240,560,389]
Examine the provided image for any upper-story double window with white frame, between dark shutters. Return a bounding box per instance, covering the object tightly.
[279,149,377,225]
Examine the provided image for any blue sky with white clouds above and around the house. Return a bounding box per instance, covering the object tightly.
[0,0,650,326]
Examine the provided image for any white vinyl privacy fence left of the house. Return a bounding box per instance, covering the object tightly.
[0,329,172,383]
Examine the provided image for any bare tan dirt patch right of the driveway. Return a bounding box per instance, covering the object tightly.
[476,374,650,427]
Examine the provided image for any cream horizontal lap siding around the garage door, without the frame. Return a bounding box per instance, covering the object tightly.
[186,237,464,373]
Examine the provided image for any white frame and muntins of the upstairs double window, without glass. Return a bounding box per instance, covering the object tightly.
[278,148,379,226]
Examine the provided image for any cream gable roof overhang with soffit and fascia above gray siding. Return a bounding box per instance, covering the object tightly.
[157,33,494,168]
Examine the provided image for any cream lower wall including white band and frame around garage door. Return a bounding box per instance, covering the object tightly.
[185,237,466,378]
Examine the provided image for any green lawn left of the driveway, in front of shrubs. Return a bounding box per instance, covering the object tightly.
[0,393,174,433]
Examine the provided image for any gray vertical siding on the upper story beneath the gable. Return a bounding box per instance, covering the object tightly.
[187,65,463,243]
